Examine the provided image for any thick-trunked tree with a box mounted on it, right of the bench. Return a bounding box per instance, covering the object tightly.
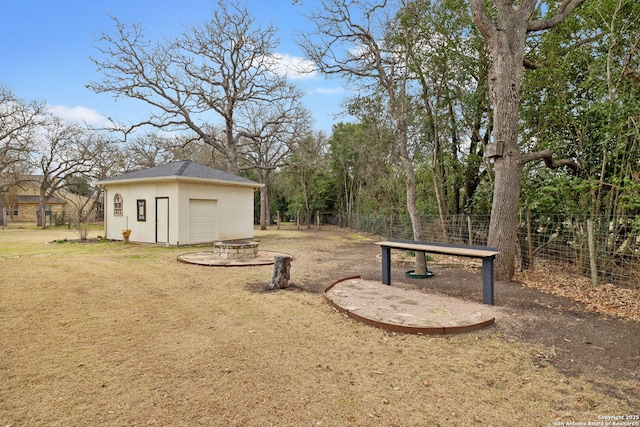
[469,0,584,280]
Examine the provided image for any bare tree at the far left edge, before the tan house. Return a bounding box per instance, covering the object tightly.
[0,84,45,226]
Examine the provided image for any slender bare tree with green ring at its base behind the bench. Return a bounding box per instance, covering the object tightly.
[300,0,426,274]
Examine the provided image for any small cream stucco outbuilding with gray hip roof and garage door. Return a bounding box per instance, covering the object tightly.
[98,160,262,245]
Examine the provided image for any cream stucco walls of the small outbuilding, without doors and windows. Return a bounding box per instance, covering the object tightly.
[103,180,255,245]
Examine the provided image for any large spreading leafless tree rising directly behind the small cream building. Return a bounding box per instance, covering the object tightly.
[88,0,304,173]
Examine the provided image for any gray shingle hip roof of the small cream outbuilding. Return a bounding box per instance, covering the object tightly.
[100,160,260,187]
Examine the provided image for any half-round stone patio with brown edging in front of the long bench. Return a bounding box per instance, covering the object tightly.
[324,277,498,334]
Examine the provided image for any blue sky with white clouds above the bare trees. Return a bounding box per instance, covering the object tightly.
[0,0,348,134]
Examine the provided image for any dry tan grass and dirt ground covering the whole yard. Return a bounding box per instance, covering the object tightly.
[0,228,640,427]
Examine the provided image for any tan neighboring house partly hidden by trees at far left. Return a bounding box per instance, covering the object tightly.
[2,175,102,223]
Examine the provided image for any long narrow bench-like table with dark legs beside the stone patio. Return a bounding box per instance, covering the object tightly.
[375,239,500,305]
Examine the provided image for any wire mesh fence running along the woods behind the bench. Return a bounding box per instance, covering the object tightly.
[321,213,640,289]
